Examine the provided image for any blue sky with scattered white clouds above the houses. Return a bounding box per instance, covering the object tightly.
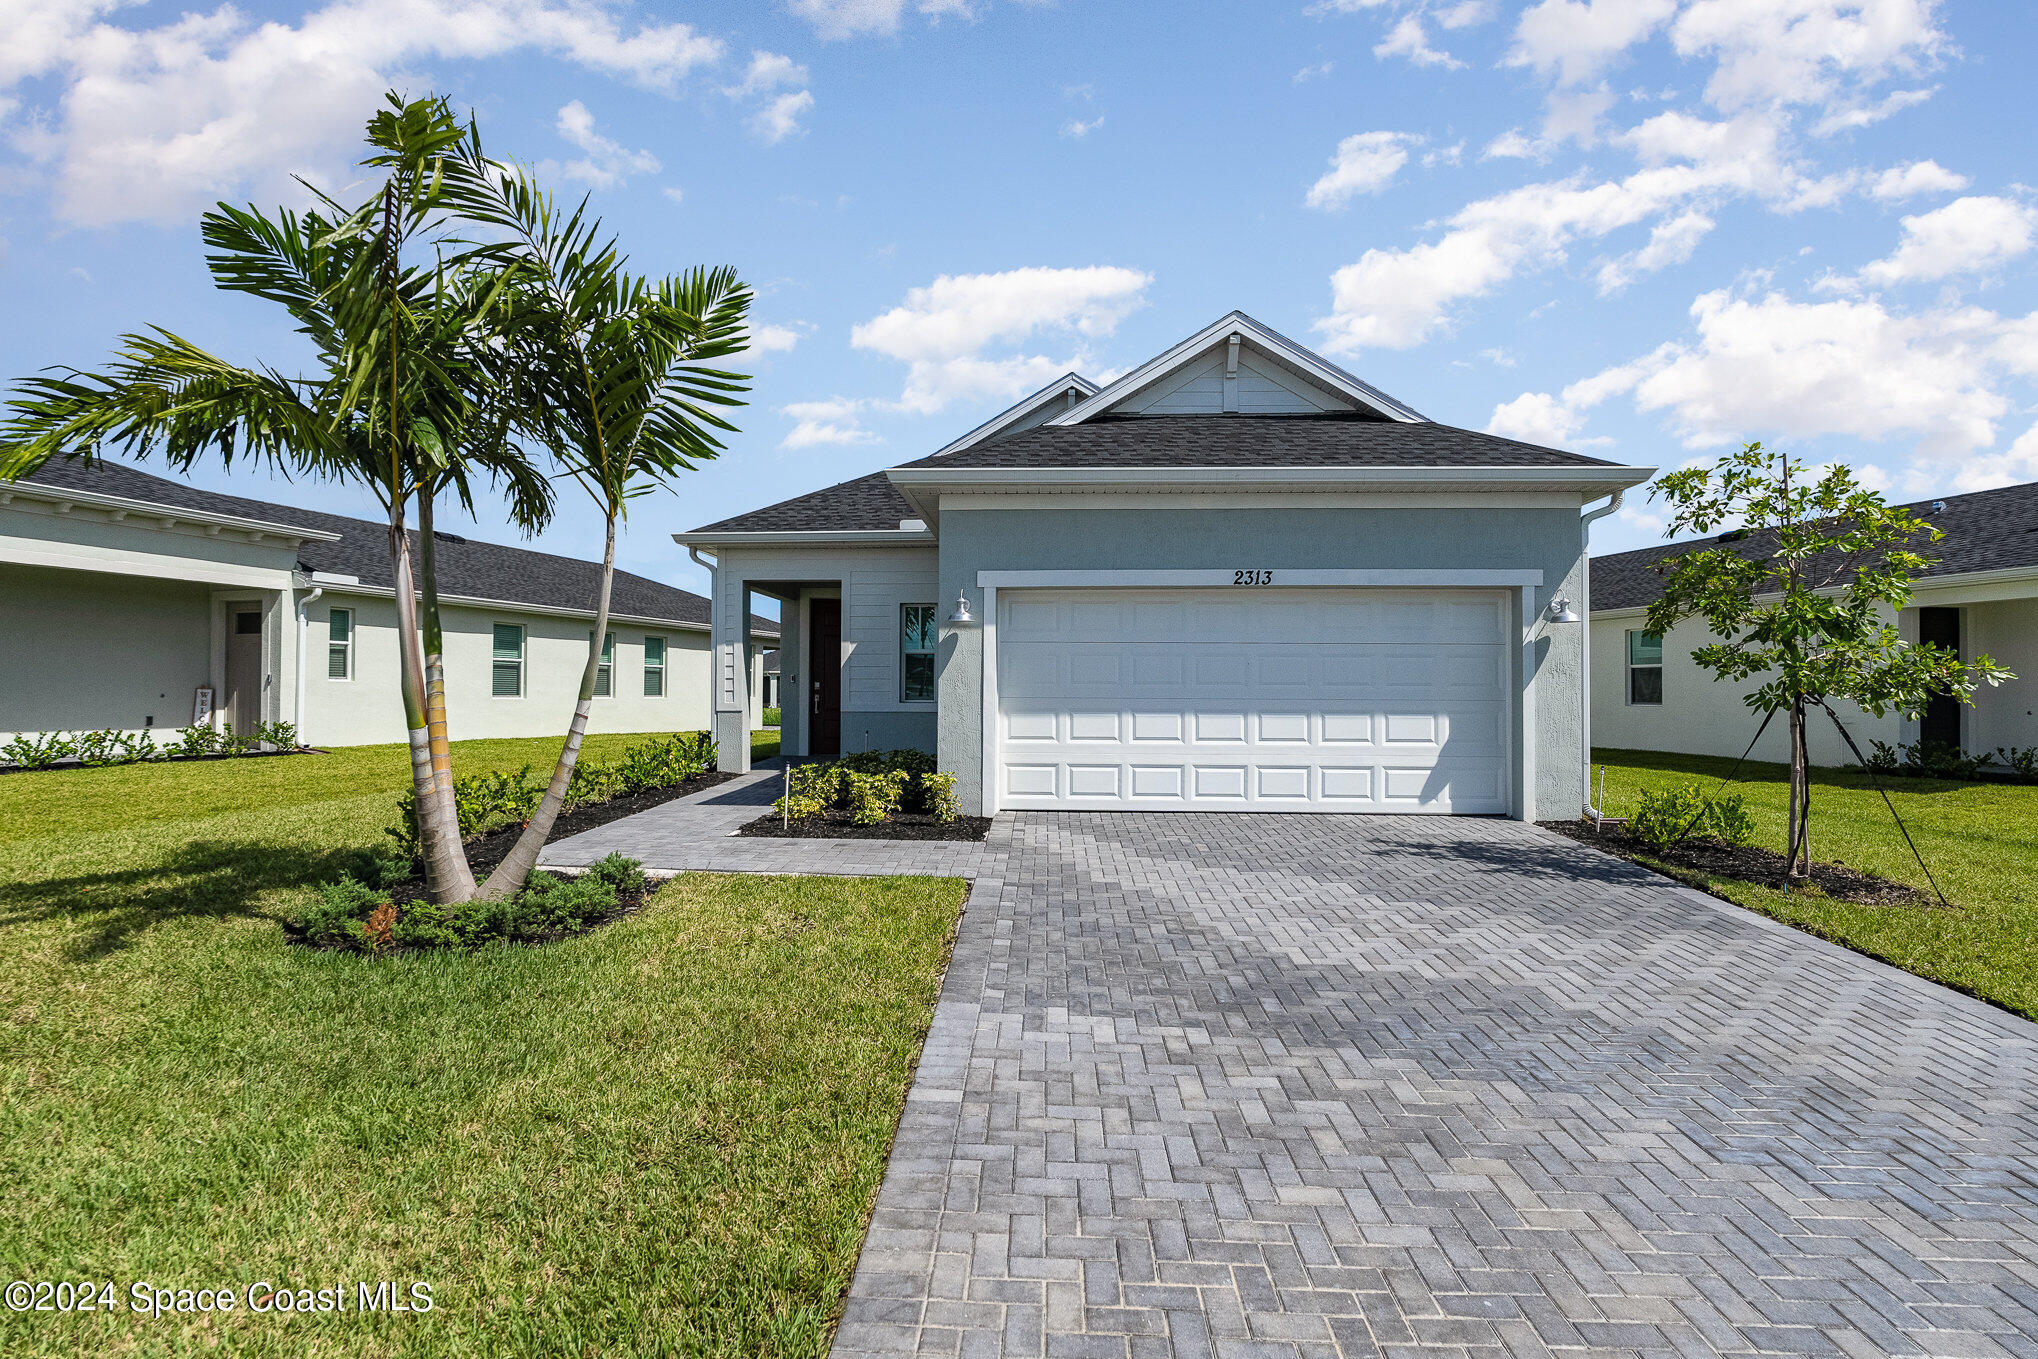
[0,0,2038,607]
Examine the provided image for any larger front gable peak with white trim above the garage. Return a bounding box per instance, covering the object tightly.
[1048,308,1425,426]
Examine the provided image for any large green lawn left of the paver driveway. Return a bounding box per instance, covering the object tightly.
[0,736,962,1359]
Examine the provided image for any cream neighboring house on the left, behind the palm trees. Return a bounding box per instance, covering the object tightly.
[0,463,774,746]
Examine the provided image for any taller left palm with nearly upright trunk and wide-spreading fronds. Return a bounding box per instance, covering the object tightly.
[0,94,550,901]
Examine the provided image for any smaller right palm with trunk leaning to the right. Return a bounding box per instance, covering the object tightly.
[457,171,750,896]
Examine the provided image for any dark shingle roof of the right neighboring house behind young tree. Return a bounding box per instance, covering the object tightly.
[1592,481,2038,609]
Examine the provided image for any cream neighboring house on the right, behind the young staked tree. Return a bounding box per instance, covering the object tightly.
[1590,483,2038,766]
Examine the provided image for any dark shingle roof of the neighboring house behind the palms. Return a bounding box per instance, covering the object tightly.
[24,460,779,636]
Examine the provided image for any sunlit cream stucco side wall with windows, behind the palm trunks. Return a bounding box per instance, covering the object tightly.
[302,587,709,746]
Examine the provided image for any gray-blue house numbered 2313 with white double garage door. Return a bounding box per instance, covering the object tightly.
[677,312,1651,817]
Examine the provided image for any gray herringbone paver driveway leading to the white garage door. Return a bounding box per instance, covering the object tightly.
[836,813,2038,1359]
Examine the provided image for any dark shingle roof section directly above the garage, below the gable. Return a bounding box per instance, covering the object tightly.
[907,416,1614,471]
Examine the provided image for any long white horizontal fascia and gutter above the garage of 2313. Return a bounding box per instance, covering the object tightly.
[884,467,1657,491]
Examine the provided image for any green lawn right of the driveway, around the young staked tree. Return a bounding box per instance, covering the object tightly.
[1594,750,2038,1019]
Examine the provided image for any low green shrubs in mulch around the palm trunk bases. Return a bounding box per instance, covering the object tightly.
[291,854,650,956]
